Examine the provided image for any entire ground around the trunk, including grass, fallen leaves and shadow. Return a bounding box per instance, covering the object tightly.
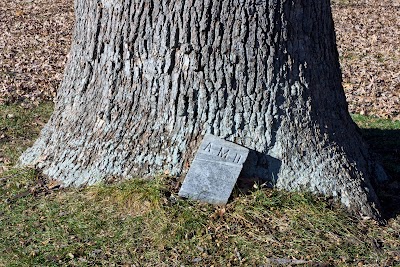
[0,0,400,266]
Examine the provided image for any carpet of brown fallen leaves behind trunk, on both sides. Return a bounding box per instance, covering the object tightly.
[0,0,400,120]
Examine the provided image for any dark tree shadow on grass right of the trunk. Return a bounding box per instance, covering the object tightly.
[361,128,400,219]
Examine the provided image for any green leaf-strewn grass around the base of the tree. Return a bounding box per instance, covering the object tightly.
[0,104,400,266]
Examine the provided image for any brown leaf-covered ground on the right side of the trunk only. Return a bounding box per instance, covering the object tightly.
[333,0,400,120]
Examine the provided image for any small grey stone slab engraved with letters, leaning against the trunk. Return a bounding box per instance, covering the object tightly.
[179,134,249,205]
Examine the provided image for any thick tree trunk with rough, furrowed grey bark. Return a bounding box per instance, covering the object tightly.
[20,0,385,218]
